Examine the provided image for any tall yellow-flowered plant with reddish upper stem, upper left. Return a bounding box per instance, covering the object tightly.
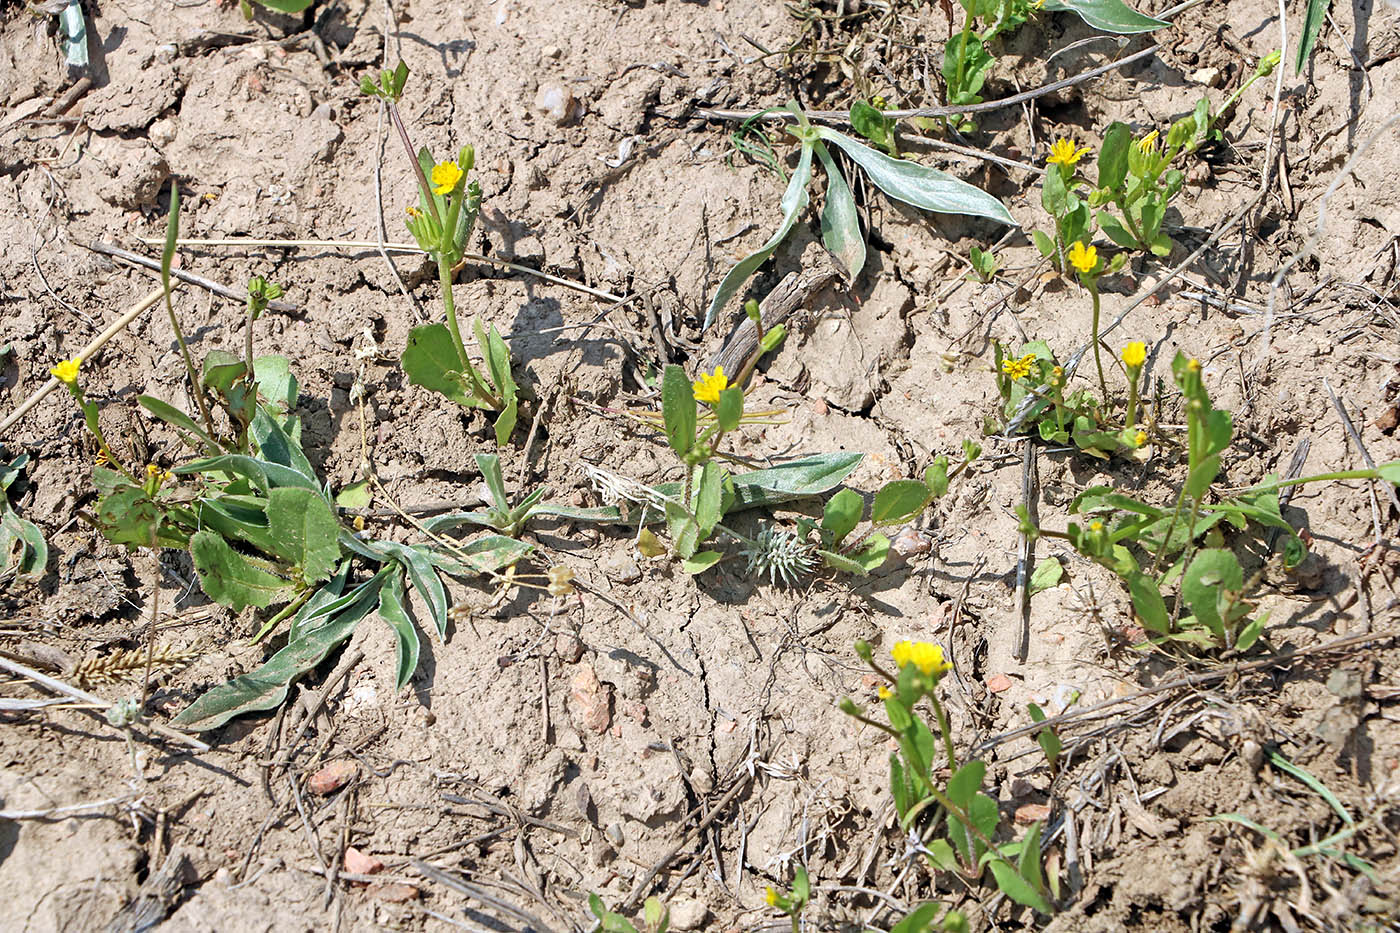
[360,62,518,445]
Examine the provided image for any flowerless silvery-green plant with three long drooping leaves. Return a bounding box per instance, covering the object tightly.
[704,101,1016,329]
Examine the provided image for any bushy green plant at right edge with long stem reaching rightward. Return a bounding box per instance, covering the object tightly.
[1018,353,1400,651]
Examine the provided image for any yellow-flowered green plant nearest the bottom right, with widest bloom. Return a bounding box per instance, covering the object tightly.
[841,642,1057,913]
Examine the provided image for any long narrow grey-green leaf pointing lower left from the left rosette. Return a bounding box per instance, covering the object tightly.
[171,572,388,731]
